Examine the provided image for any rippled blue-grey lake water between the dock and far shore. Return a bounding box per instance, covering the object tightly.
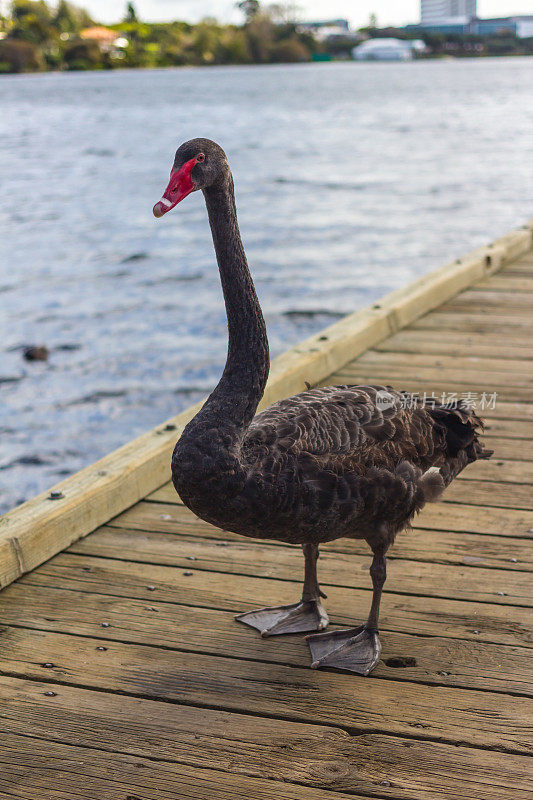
[0,58,533,510]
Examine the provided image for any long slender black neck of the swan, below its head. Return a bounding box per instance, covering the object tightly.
[196,174,269,431]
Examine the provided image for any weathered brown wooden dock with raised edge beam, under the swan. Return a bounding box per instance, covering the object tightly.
[0,226,533,800]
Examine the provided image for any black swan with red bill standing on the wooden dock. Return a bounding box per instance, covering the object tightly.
[154,139,491,675]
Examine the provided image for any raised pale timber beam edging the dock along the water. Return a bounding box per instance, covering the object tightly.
[0,225,532,587]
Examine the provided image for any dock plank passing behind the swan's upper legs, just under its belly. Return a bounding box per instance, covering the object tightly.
[66,523,533,577]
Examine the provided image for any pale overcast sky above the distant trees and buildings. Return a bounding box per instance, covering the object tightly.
[82,0,533,28]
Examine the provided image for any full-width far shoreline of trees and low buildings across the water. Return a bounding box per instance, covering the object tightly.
[0,0,533,73]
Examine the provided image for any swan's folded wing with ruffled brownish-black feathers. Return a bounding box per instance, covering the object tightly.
[244,386,446,474]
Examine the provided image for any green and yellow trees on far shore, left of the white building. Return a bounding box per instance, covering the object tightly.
[0,0,319,73]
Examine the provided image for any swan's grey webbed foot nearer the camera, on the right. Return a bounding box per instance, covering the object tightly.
[306,625,381,675]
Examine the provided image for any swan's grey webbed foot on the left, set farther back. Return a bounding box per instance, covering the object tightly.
[235,600,329,636]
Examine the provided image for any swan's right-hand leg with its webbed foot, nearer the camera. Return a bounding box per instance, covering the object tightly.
[306,549,387,675]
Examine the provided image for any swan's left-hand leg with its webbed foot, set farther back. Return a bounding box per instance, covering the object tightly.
[235,544,329,636]
